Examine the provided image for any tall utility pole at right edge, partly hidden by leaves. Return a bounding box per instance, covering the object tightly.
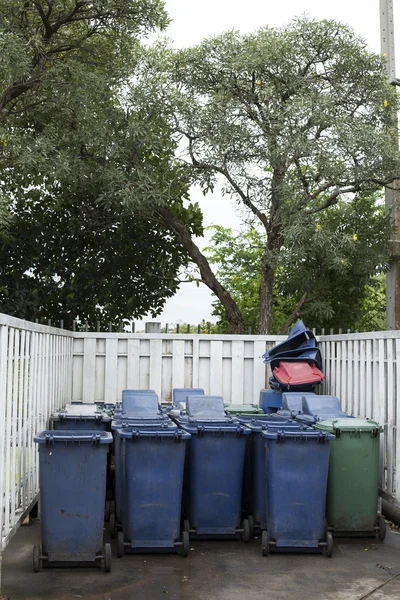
[380,0,400,329]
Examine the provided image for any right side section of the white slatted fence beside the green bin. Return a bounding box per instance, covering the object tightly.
[318,331,400,505]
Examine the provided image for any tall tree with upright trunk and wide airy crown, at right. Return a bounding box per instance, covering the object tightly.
[147,19,400,333]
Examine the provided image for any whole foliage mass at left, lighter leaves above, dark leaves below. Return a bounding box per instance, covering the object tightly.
[0,0,201,326]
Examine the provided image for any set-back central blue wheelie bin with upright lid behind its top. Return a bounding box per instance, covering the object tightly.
[176,396,251,542]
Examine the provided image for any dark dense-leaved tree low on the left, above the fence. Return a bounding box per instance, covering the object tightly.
[0,185,197,329]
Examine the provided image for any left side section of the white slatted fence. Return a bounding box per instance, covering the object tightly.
[0,314,72,554]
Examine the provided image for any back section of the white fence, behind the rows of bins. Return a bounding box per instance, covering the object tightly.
[72,333,284,404]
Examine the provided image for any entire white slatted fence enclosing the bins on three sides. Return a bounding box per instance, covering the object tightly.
[0,314,400,564]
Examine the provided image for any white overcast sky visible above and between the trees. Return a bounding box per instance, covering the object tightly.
[137,0,400,324]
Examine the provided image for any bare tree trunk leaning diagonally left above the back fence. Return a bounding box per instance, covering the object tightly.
[157,204,244,333]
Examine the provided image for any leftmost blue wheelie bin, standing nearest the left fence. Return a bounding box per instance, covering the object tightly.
[33,430,112,572]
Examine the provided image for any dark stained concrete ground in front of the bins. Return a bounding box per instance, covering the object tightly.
[2,522,400,600]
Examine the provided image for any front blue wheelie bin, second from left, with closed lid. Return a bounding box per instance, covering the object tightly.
[116,421,190,557]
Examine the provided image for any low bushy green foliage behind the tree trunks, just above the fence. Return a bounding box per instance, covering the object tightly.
[207,195,390,333]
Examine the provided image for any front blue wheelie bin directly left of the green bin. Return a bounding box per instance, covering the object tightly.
[261,428,335,557]
